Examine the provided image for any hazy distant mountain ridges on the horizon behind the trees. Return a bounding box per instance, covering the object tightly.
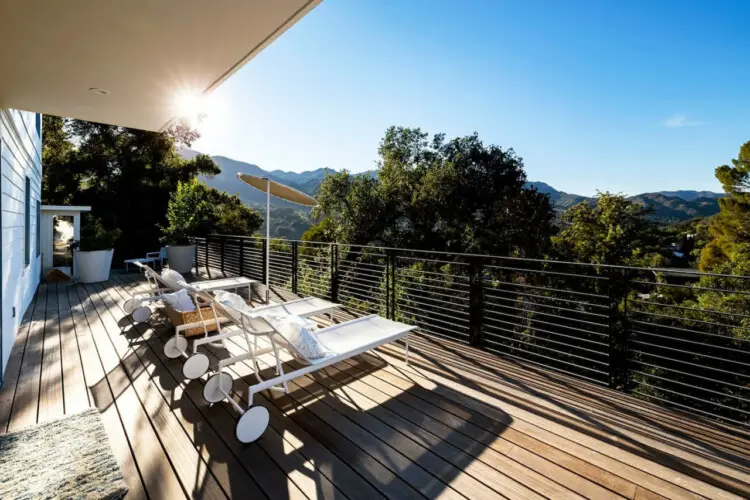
[180,149,723,226]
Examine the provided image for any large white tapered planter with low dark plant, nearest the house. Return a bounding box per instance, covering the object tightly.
[73,216,122,283]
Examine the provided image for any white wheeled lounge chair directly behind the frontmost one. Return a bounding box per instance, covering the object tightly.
[172,284,340,380]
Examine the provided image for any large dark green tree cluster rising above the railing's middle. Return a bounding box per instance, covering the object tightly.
[313,127,554,256]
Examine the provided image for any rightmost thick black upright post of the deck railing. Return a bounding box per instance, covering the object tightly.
[607,268,630,392]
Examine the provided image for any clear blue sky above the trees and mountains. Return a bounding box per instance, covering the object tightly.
[194,0,750,195]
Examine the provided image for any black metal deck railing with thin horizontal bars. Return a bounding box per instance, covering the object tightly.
[195,235,750,426]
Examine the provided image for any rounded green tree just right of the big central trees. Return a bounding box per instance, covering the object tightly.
[552,193,657,265]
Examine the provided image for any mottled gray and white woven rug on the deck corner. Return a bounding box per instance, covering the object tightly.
[0,408,128,499]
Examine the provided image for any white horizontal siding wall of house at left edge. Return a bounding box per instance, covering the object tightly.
[0,109,42,382]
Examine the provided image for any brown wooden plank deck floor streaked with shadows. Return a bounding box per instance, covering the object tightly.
[0,275,750,499]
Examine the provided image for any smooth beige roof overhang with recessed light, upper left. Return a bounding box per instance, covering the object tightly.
[0,0,321,131]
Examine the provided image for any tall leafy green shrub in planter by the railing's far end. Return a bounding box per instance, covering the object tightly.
[161,179,206,274]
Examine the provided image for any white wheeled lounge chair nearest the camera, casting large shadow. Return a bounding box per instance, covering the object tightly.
[203,296,416,443]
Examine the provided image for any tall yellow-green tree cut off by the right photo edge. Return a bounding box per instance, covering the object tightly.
[700,141,750,271]
